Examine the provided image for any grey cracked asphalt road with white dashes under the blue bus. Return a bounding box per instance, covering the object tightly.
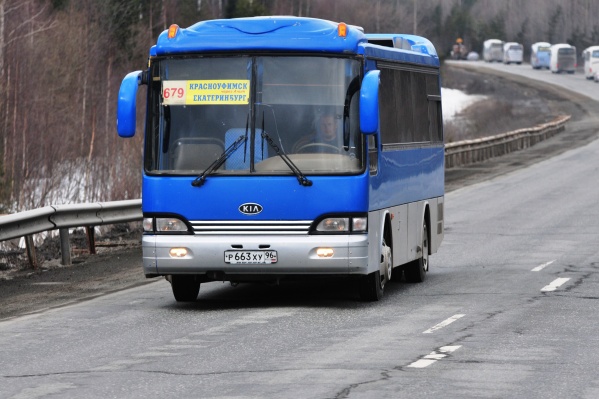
[0,62,599,398]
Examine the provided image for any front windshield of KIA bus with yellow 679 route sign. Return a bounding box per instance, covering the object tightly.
[145,55,364,175]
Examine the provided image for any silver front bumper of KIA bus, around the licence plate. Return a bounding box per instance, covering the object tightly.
[142,234,370,280]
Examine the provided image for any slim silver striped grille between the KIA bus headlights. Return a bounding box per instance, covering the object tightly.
[190,220,312,235]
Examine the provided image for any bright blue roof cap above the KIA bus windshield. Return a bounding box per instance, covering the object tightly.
[150,17,440,67]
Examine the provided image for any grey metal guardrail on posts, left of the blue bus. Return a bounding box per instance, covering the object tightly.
[0,199,142,269]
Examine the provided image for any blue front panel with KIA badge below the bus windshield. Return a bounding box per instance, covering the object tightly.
[142,174,368,221]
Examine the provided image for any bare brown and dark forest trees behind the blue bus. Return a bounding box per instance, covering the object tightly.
[0,0,599,214]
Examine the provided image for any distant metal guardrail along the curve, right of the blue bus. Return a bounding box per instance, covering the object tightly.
[445,115,571,168]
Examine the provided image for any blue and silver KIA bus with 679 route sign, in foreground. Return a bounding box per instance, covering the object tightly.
[117,17,444,302]
